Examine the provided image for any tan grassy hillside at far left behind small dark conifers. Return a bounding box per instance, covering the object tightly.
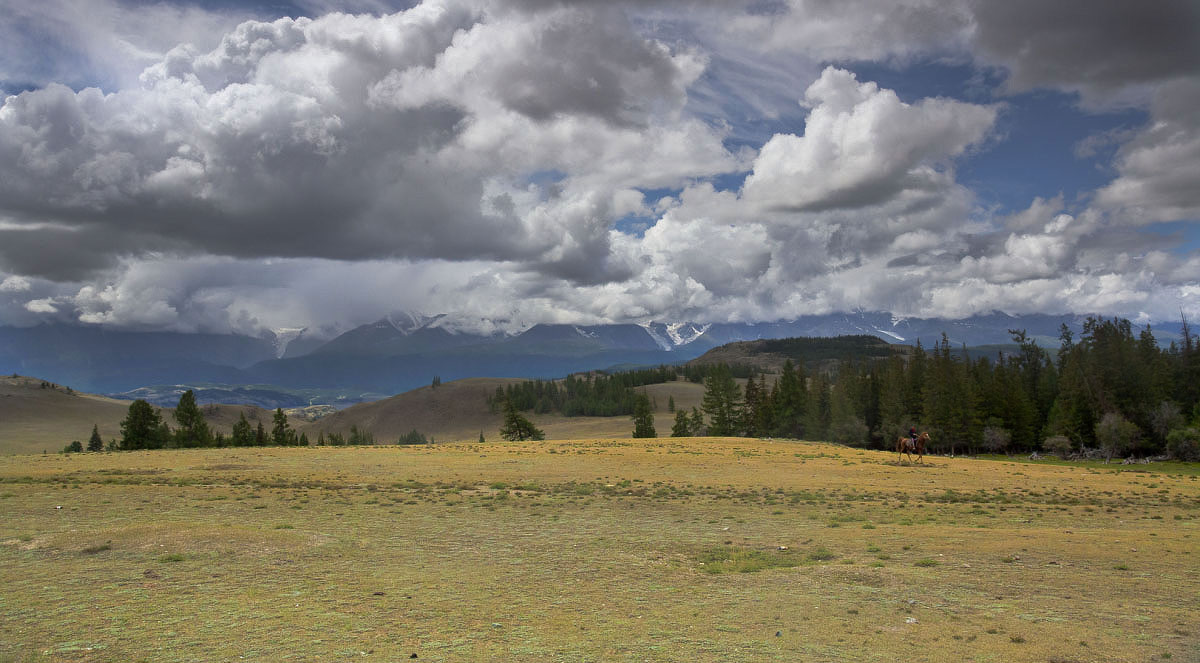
[0,376,304,454]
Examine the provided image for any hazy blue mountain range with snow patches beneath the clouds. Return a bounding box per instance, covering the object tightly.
[0,311,1181,406]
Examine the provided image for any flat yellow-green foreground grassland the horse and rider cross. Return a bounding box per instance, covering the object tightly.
[0,440,1200,662]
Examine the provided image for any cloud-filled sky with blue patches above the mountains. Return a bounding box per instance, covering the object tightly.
[0,0,1200,336]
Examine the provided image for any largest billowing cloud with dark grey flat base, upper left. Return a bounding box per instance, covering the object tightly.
[0,1,740,279]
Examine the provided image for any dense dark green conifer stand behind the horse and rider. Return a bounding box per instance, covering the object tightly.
[673,317,1200,460]
